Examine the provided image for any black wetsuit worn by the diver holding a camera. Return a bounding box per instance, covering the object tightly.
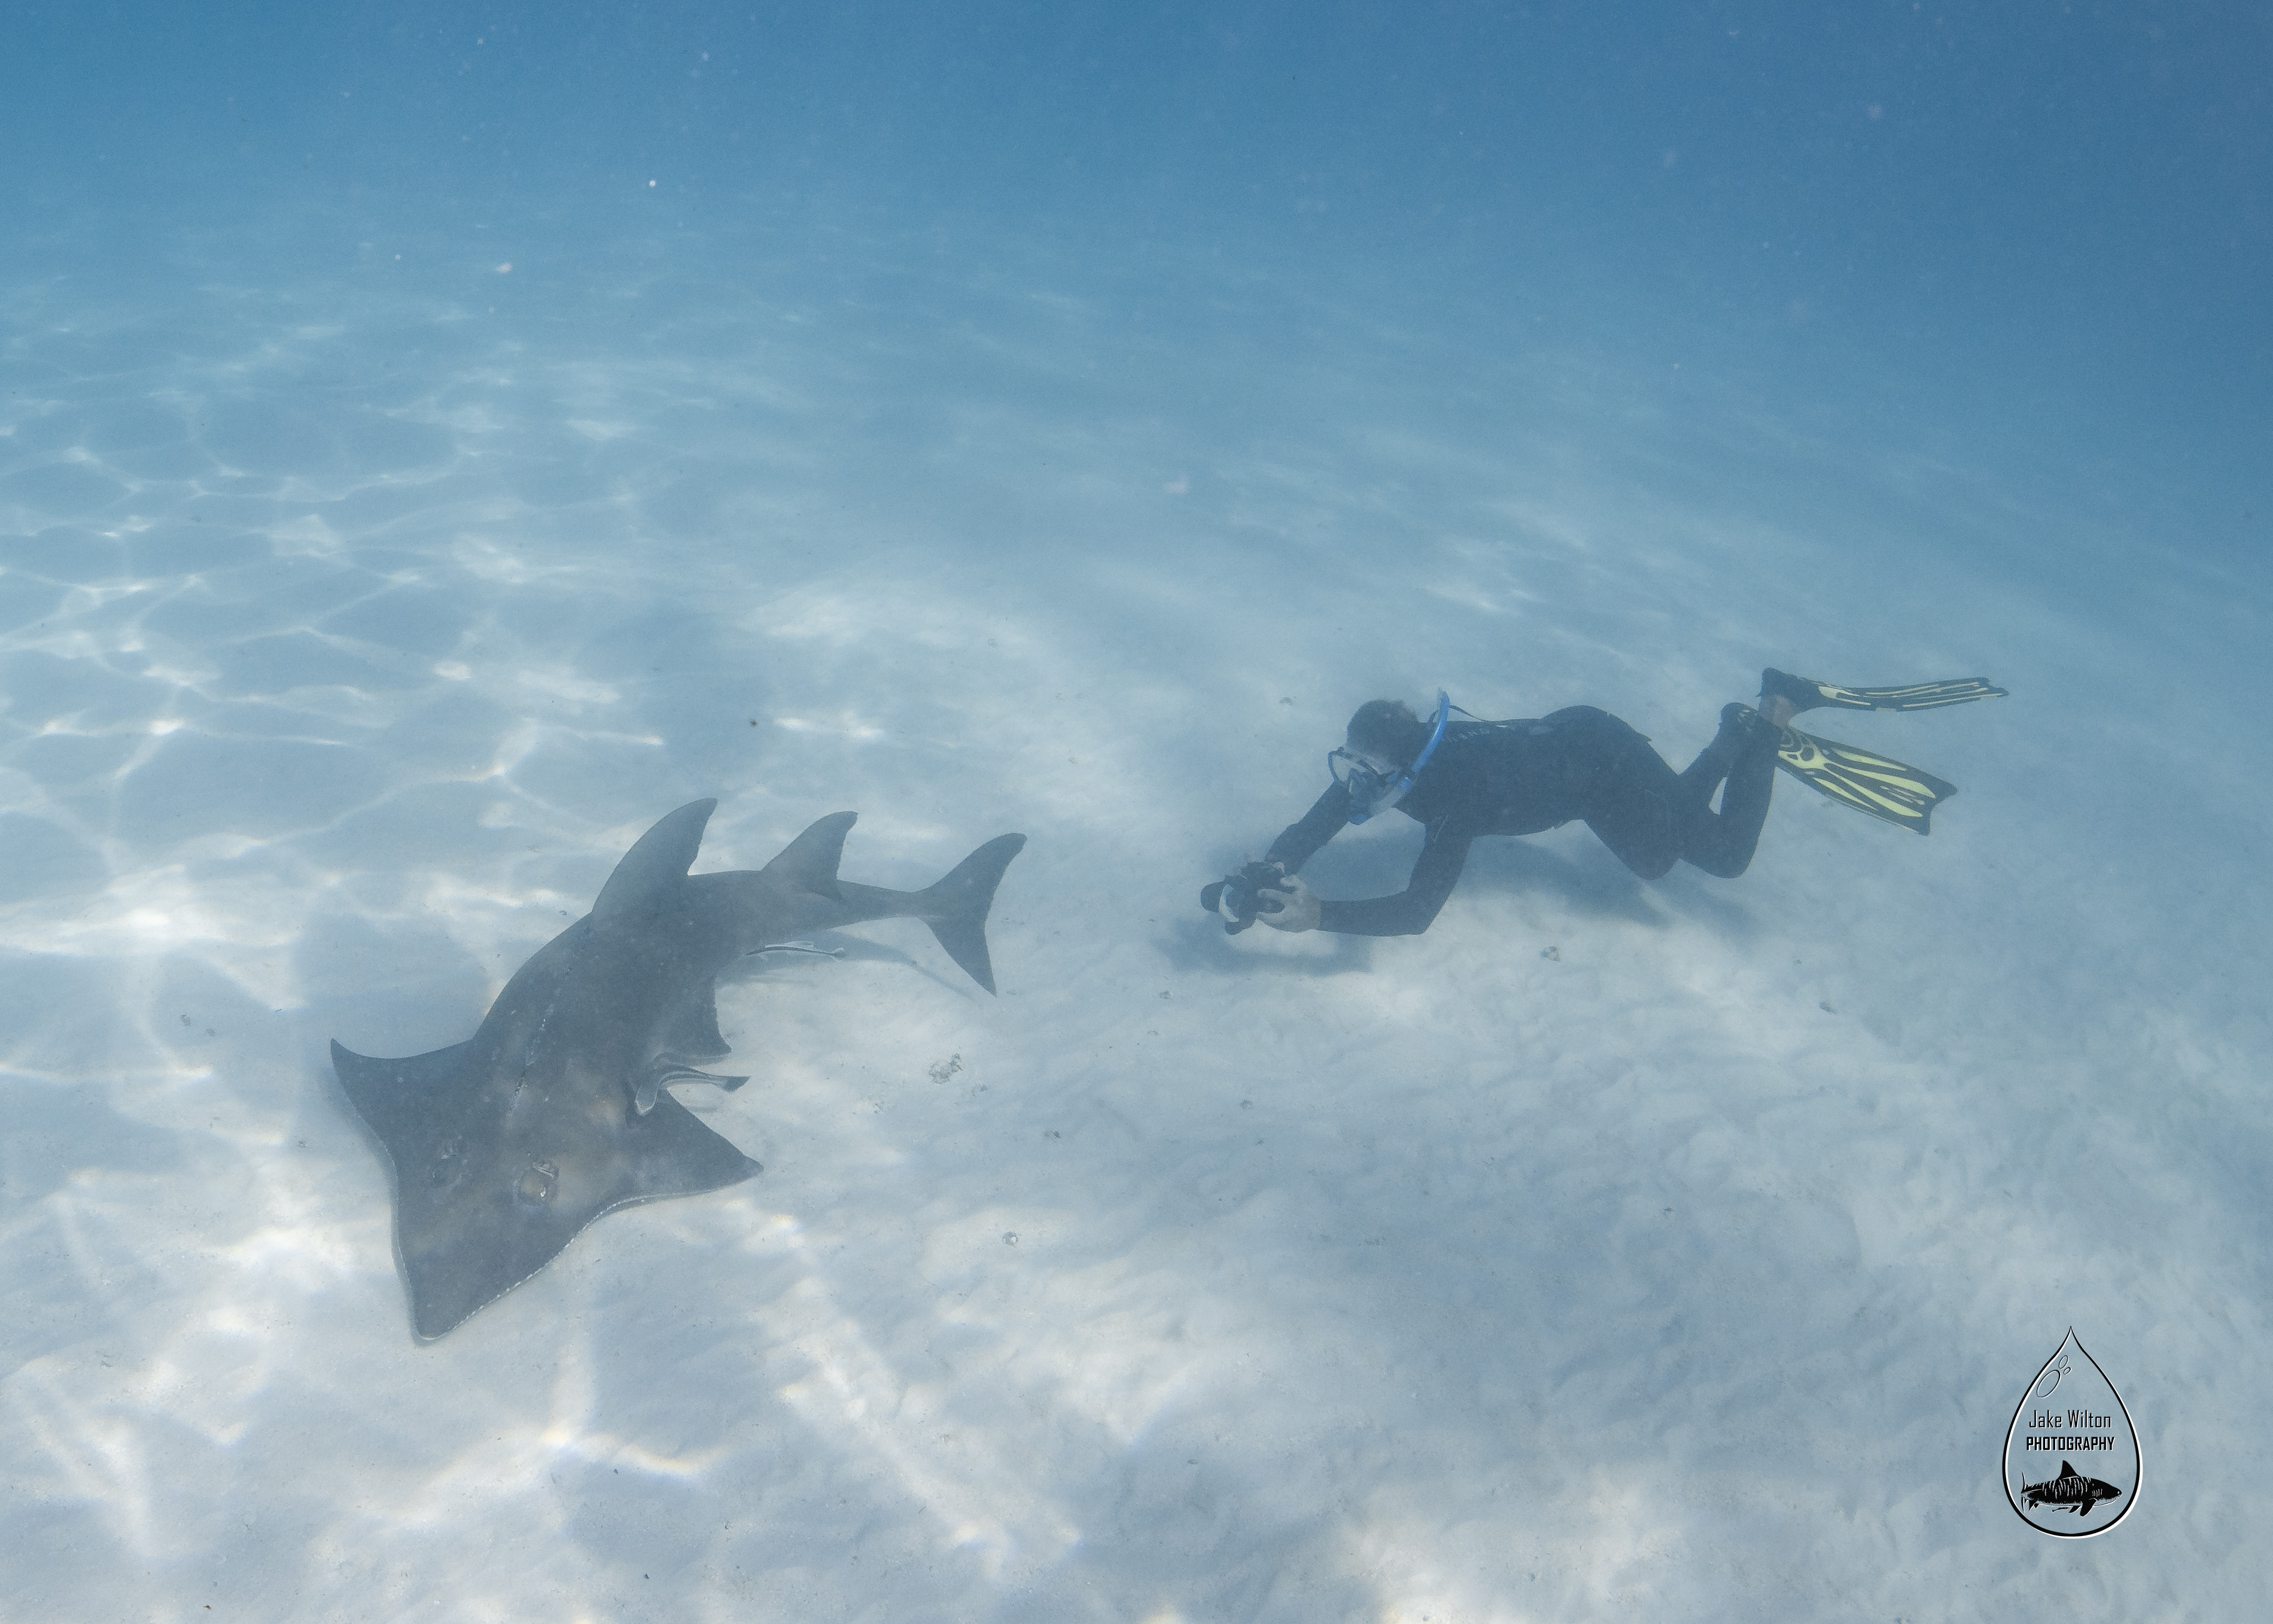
[1264,705,1775,937]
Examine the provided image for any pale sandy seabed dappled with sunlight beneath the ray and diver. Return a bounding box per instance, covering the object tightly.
[0,209,2268,1624]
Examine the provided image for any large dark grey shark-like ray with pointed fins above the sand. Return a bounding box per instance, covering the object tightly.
[332,801,1025,1342]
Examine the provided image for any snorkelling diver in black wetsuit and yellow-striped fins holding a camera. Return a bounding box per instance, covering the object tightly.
[1200,667,2005,937]
